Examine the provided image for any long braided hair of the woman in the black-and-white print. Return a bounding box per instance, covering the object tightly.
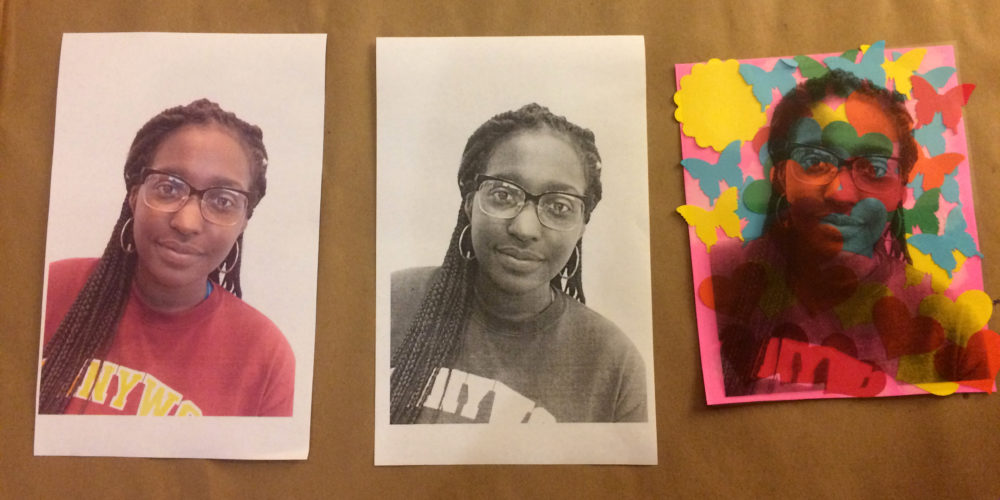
[390,103,601,424]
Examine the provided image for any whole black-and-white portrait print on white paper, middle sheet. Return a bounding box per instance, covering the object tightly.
[375,37,656,465]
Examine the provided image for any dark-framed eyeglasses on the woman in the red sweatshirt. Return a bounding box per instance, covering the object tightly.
[141,169,250,226]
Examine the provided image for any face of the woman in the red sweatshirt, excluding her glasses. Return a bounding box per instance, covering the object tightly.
[129,124,252,294]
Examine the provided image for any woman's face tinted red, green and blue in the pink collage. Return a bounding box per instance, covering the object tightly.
[777,97,905,256]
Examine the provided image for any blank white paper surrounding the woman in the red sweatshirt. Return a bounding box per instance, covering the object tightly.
[34,33,326,459]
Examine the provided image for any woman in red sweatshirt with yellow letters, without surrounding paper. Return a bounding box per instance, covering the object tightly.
[38,99,295,416]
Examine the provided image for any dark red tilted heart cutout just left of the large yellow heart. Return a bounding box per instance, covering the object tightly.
[872,296,945,359]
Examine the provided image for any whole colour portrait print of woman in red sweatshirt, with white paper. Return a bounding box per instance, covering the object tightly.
[35,33,326,459]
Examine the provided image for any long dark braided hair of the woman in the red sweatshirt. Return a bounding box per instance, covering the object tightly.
[38,99,267,414]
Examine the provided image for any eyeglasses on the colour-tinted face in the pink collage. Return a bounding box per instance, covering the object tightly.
[788,143,900,193]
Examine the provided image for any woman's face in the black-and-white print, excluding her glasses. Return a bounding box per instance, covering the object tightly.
[465,129,587,295]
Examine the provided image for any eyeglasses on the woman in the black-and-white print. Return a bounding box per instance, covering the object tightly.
[476,174,584,231]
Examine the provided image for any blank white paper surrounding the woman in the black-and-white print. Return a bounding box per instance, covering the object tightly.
[375,36,657,465]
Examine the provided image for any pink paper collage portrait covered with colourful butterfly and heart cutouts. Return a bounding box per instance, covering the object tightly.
[674,41,1000,404]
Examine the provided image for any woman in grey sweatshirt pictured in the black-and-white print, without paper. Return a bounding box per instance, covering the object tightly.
[390,103,649,424]
